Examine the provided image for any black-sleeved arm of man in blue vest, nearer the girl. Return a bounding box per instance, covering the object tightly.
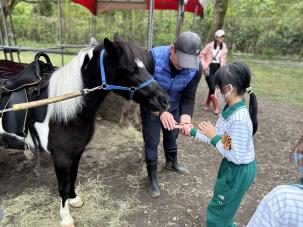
[180,64,202,119]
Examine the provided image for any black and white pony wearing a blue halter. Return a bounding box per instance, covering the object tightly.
[0,36,168,226]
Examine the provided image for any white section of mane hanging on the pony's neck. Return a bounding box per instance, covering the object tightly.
[48,48,93,123]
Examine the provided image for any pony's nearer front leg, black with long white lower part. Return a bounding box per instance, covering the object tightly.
[52,153,74,227]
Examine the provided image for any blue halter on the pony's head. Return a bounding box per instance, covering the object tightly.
[100,49,154,99]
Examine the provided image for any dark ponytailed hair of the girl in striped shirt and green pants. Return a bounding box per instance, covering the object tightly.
[214,62,258,135]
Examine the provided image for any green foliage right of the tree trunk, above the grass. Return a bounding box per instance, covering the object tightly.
[224,0,303,56]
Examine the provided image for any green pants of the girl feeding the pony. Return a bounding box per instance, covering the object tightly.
[206,159,256,227]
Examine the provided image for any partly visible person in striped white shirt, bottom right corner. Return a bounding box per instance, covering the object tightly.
[247,135,303,227]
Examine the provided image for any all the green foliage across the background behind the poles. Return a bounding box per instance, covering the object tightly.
[4,0,303,56]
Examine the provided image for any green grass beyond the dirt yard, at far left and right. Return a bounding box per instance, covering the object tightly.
[0,52,303,106]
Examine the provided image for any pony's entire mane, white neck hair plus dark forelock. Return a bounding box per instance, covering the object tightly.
[48,40,148,123]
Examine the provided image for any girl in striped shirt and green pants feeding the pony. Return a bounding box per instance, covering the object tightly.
[184,62,258,227]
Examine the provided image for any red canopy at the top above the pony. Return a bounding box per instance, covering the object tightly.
[72,0,205,17]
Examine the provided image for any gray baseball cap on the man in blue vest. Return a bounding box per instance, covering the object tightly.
[174,32,201,70]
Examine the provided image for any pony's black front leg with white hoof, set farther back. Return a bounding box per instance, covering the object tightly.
[69,152,84,208]
